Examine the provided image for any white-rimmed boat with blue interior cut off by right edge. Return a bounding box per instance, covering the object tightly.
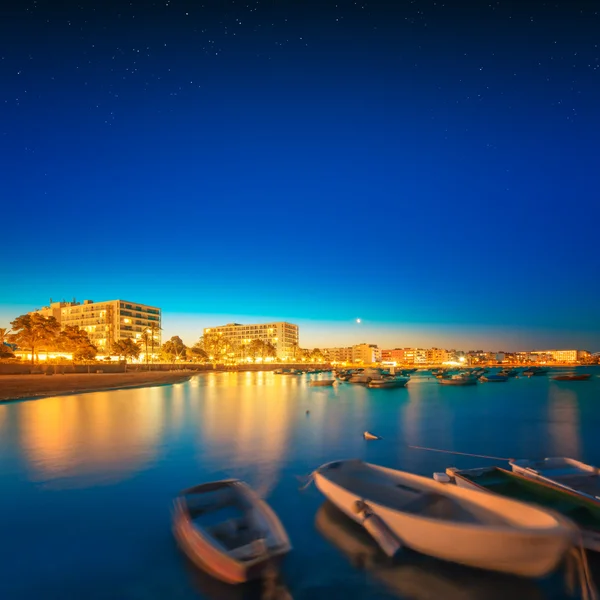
[508,457,600,505]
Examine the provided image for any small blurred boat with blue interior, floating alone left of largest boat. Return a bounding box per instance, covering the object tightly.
[173,479,291,584]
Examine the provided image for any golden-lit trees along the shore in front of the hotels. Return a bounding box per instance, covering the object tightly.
[0,313,325,364]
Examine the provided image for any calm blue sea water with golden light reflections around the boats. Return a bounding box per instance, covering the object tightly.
[0,369,600,600]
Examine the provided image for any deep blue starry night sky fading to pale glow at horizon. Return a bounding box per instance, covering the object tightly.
[0,0,600,350]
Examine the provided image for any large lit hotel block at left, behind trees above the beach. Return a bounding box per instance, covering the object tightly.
[34,300,161,354]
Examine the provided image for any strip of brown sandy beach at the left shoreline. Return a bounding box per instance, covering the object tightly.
[0,371,194,402]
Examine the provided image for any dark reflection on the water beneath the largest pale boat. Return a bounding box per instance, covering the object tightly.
[315,501,544,600]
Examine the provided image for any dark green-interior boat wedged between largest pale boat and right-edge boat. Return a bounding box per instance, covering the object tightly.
[446,467,600,552]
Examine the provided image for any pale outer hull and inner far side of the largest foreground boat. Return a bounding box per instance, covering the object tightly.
[315,460,573,578]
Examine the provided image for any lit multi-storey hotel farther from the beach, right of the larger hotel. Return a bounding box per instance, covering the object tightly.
[204,321,298,360]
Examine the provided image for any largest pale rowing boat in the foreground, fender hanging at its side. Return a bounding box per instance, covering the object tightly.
[314,460,575,577]
